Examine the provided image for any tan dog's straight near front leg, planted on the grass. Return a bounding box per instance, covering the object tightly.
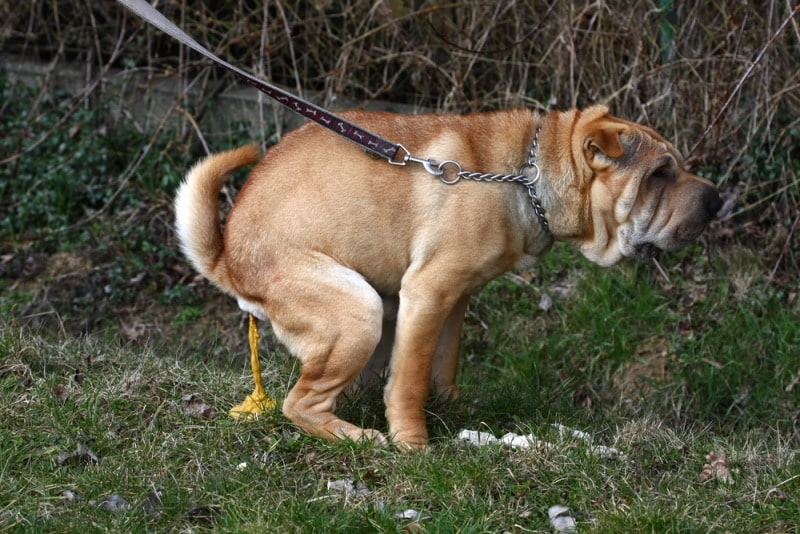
[384,284,466,448]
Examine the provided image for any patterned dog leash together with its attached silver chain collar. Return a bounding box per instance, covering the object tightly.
[117,0,550,235]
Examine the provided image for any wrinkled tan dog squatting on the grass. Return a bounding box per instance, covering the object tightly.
[175,106,720,447]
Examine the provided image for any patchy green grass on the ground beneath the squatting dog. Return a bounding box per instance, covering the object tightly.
[0,244,800,532]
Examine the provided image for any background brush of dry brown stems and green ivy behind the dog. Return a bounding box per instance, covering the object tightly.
[0,0,800,326]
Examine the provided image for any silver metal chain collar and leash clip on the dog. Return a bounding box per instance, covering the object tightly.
[389,126,550,235]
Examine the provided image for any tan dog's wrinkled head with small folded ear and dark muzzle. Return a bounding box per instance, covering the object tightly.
[573,114,721,265]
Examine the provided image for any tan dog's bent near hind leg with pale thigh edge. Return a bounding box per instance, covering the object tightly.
[266,260,385,442]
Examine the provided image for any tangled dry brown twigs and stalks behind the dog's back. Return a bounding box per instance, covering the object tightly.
[0,0,800,281]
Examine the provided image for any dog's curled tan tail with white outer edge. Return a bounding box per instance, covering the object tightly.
[175,145,261,293]
